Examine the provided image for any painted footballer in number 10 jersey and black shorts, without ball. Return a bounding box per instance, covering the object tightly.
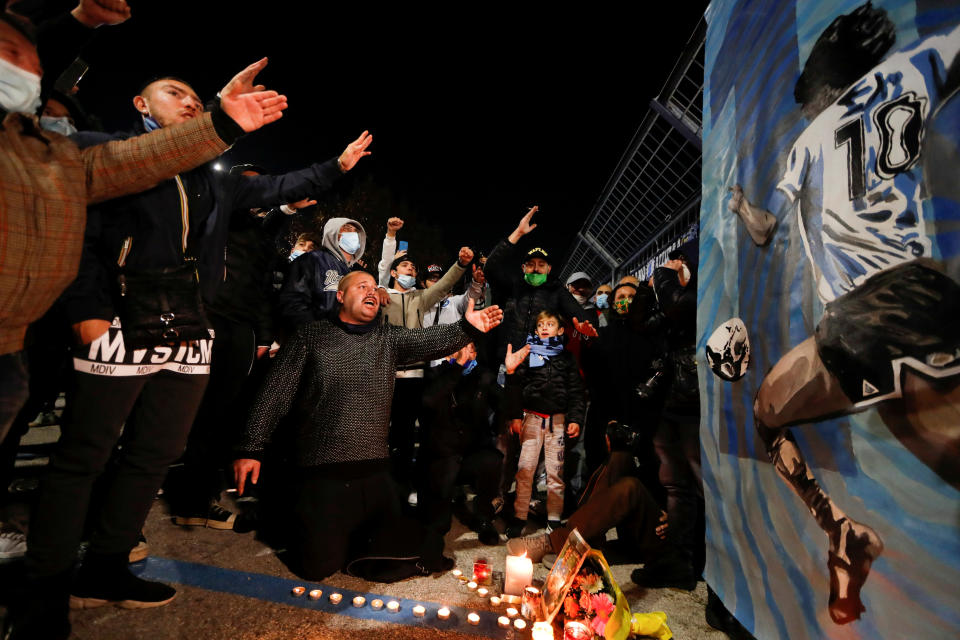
[728,3,960,624]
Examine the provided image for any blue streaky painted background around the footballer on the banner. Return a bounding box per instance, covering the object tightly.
[697,0,960,640]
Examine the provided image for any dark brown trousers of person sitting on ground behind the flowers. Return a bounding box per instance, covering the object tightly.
[550,451,673,559]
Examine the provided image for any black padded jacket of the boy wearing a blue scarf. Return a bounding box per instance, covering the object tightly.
[507,351,587,426]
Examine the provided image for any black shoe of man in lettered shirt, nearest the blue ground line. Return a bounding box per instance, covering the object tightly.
[70,553,177,609]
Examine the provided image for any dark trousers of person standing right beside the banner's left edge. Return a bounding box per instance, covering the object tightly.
[653,410,704,564]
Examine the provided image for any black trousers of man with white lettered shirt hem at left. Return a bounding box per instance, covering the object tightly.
[27,370,207,578]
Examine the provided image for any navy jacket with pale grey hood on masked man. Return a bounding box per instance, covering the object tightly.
[279,218,367,327]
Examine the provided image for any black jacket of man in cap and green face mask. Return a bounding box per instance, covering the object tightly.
[484,239,594,353]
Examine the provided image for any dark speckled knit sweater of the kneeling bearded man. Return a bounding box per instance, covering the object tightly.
[237,317,477,472]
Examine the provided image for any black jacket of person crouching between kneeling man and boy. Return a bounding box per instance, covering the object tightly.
[421,362,502,458]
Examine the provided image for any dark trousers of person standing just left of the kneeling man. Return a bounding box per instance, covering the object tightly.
[168,314,256,515]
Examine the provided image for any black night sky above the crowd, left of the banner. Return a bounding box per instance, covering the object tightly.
[31,0,705,266]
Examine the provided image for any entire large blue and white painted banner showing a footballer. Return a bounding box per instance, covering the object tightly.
[697,0,960,640]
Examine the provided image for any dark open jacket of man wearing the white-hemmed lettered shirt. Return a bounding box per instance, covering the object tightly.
[57,125,341,322]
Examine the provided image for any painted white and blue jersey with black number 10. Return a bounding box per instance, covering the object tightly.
[777,27,960,302]
